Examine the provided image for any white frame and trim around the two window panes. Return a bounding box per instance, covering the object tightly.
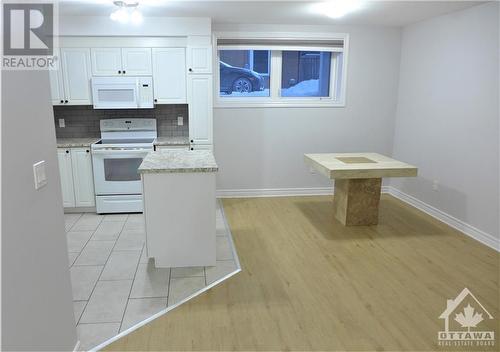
[213,32,349,108]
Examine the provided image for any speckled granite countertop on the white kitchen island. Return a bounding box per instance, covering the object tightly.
[139,150,219,173]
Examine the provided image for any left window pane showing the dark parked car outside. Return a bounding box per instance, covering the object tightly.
[219,50,270,97]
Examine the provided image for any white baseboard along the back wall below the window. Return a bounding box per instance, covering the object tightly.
[217,186,388,198]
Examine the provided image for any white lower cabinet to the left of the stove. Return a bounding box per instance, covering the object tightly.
[57,148,95,208]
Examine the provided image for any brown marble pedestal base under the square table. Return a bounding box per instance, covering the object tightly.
[333,178,382,226]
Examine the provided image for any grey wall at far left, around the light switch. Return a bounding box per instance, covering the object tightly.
[1,71,77,351]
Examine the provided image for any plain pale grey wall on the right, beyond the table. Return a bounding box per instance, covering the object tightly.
[391,3,500,238]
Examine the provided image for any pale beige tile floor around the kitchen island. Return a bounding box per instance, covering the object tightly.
[64,204,239,350]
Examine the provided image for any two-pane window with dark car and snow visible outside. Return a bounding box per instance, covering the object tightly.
[216,34,347,107]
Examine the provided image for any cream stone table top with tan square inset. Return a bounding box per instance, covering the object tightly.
[304,153,418,179]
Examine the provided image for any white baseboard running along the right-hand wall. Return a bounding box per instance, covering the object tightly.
[387,186,500,252]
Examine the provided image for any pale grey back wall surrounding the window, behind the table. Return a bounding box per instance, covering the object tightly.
[214,25,400,190]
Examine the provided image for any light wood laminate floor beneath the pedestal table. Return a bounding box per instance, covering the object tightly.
[106,195,500,351]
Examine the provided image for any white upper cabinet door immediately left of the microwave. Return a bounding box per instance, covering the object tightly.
[61,48,92,105]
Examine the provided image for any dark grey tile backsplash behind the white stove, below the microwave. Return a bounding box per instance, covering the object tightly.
[54,104,189,138]
